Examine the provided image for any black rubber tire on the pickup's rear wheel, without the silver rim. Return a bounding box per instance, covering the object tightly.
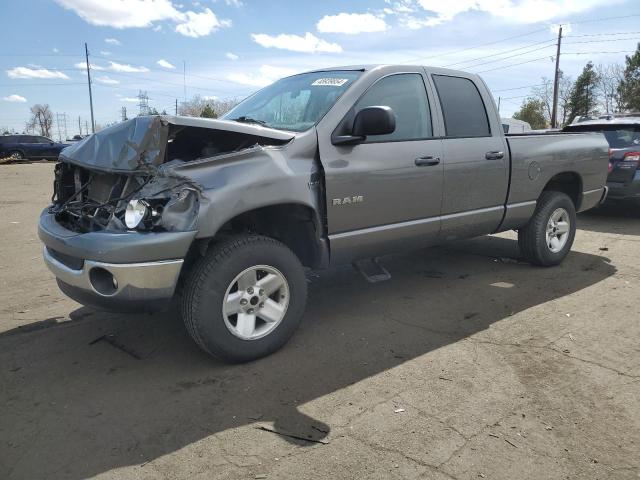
[518,191,576,267]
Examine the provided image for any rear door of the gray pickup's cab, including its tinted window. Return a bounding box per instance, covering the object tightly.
[431,74,509,239]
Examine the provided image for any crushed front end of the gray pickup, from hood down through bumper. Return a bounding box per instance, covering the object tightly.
[38,116,292,311]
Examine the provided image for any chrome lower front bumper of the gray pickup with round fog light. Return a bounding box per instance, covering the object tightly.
[44,247,184,310]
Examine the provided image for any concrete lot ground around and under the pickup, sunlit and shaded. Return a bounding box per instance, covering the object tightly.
[0,163,640,480]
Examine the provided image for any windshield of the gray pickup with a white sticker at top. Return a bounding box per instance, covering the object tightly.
[222,70,361,132]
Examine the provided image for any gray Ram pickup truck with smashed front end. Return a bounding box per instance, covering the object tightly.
[39,66,609,361]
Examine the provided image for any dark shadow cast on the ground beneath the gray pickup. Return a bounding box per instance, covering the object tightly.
[0,237,615,479]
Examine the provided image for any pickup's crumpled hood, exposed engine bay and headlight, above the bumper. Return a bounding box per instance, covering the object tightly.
[49,117,289,232]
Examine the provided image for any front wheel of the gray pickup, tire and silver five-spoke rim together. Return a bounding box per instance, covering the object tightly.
[182,235,307,362]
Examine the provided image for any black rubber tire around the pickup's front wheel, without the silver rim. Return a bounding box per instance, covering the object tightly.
[181,235,307,363]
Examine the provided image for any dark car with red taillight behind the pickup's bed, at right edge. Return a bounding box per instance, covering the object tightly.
[564,113,640,203]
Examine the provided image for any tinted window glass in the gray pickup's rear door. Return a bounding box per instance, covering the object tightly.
[432,75,491,137]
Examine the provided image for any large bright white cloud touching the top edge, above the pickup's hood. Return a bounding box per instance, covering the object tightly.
[55,0,231,37]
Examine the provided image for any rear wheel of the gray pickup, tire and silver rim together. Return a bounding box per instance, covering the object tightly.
[518,191,576,267]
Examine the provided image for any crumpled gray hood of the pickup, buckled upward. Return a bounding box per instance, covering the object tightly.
[60,115,295,173]
